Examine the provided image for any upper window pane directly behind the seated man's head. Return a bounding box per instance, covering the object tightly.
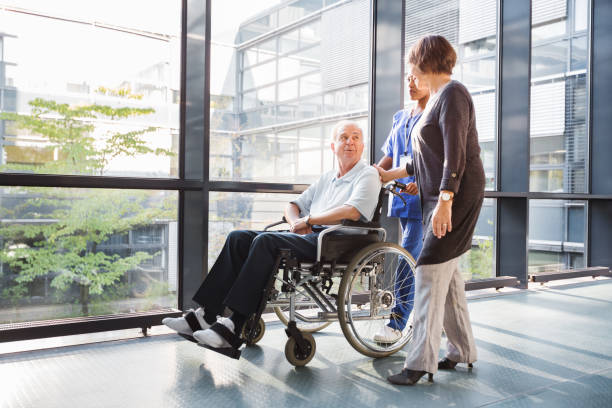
[209,0,370,183]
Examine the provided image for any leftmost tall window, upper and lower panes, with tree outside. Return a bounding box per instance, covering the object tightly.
[0,0,181,324]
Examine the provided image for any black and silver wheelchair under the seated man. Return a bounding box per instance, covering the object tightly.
[243,182,415,366]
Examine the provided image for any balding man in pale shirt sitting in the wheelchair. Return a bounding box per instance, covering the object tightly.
[162,121,381,358]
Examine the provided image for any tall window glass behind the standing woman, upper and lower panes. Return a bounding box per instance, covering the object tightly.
[404,0,497,279]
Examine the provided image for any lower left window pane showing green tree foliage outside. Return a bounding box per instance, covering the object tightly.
[0,187,178,324]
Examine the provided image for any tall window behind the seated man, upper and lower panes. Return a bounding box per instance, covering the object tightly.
[208,0,370,266]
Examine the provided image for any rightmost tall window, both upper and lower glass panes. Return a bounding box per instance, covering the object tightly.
[529,0,589,273]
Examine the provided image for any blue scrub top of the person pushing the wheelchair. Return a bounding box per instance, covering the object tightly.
[381,110,423,220]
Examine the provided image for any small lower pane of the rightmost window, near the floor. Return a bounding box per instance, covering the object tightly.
[528,200,586,275]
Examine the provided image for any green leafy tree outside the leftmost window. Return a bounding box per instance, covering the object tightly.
[0,99,175,315]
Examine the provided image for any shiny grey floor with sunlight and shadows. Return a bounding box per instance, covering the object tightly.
[0,280,612,408]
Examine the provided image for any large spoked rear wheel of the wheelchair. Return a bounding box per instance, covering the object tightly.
[338,242,416,358]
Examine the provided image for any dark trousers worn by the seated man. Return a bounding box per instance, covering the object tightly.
[193,231,319,316]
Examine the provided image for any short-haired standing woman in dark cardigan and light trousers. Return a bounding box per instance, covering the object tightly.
[378,36,485,385]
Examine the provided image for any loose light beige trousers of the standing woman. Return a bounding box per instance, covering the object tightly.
[404,257,476,373]
